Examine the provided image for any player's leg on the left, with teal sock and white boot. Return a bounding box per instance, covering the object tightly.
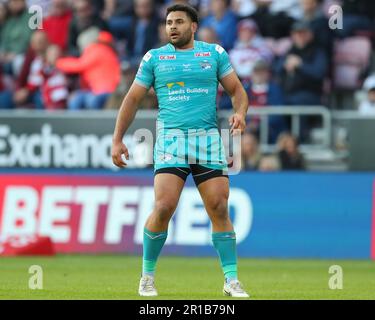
[139,168,189,296]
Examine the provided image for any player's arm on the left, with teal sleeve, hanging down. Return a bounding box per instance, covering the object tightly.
[112,52,154,168]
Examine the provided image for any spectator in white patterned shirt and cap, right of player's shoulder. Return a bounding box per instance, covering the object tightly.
[229,19,273,80]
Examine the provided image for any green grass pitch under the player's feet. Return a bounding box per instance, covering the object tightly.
[0,255,375,300]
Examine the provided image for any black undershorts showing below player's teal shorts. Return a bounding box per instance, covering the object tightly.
[155,164,228,186]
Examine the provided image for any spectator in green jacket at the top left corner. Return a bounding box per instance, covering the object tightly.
[0,0,33,75]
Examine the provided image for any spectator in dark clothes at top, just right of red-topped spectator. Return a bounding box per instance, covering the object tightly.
[68,0,108,56]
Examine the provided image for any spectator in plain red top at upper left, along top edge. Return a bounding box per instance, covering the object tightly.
[43,0,72,51]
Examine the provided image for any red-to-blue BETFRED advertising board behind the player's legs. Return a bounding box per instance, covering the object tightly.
[0,170,375,259]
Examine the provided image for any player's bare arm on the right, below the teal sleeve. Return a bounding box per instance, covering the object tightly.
[220,71,249,134]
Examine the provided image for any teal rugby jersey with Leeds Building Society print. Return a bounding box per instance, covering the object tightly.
[135,41,233,133]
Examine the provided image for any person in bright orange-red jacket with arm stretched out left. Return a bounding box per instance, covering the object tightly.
[56,31,120,110]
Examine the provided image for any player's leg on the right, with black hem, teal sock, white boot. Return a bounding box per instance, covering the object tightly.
[193,166,248,297]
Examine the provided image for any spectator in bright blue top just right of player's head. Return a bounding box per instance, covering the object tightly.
[201,0,237,50]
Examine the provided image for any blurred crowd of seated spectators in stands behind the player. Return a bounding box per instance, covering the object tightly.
[0,0,375,170]
